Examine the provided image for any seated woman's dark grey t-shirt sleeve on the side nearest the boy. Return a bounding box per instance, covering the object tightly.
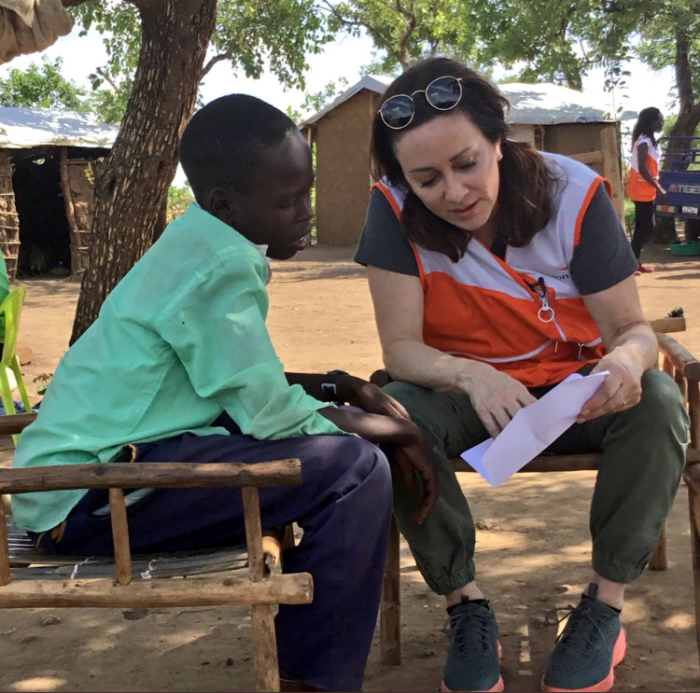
[355,188,419,277]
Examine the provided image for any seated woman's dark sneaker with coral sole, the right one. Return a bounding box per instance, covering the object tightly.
[541,584,627,693]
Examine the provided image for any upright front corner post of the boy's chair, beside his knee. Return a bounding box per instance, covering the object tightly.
[241,487,280,692]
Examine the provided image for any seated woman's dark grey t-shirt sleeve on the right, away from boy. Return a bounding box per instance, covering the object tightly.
[571,184,638,296]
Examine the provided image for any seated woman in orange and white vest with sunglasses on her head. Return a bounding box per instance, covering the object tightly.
[356,58,688,691]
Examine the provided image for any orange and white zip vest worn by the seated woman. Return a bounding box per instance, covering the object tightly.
[375,153,610,387]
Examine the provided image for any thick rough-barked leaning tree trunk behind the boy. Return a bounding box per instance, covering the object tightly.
[71,0,217,344]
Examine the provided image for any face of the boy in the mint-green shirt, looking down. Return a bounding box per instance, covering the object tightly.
[220,130,314,260]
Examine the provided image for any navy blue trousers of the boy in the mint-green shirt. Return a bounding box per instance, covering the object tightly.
[37,424,392,691]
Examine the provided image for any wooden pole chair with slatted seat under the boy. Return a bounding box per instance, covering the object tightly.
[0,414,313,691]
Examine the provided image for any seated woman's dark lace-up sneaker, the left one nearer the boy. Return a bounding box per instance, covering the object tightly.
[440,597,503,691]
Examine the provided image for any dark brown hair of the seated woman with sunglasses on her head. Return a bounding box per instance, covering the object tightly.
[372,58,554,262]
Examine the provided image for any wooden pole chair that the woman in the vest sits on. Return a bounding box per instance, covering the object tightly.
[372,317,700,664]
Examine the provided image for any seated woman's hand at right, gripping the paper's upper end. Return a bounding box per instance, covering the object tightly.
[576,352,642,424]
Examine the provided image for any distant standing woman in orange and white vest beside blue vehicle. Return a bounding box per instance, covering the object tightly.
[627,107,666,274]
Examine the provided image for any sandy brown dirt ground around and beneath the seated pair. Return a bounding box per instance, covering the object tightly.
[0,241,700,691]
